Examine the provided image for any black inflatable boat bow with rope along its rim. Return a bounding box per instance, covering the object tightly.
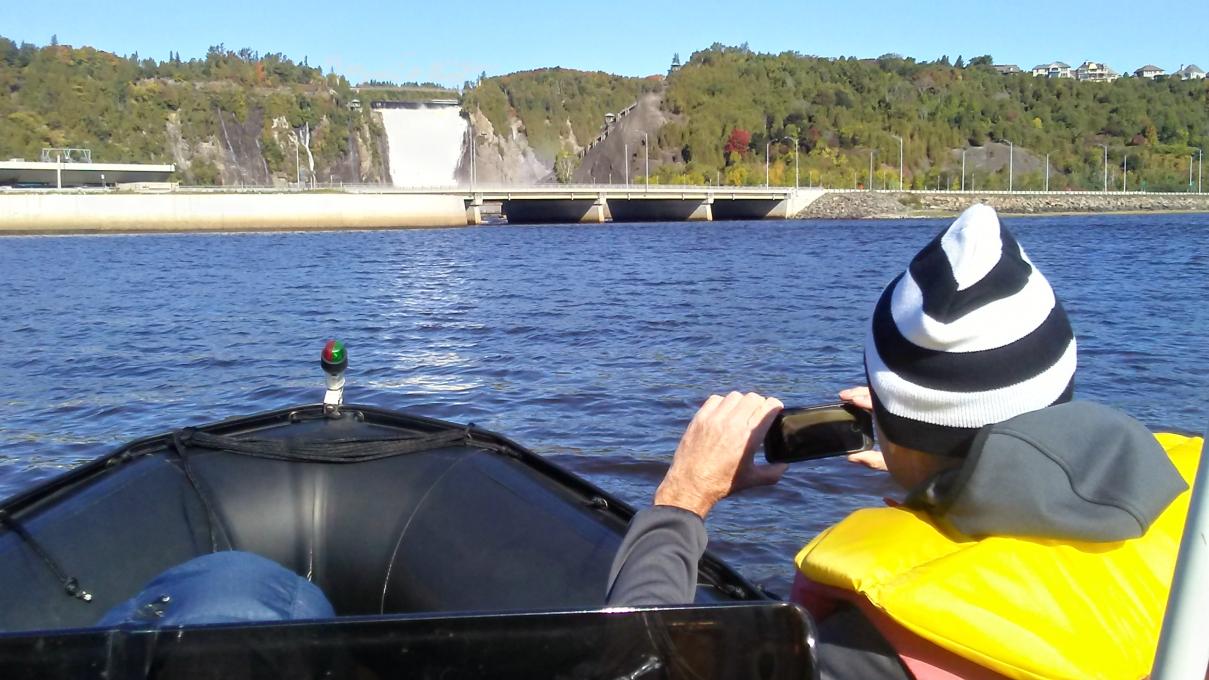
[0,341,810,678]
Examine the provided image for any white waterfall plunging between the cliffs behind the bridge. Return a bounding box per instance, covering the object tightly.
[378,105,467,186]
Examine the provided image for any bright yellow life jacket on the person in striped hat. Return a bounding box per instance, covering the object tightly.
[796,433,1203,679]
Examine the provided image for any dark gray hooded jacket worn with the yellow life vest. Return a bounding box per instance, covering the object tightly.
[607,402,1187,678]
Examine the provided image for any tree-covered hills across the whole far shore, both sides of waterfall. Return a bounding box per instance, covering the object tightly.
[7,38,1209,191]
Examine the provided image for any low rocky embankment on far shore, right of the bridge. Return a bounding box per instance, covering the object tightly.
[797,191,1209,219]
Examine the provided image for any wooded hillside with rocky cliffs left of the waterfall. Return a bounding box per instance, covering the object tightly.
[0,38,381,184]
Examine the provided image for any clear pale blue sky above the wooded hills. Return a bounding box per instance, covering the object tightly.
[0,0,1209,85]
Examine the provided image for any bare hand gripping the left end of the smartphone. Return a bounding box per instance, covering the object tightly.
[655,392,788,519]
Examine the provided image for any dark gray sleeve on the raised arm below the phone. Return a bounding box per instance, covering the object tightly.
[607,506,707,606]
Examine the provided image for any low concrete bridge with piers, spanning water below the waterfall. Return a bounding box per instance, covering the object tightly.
[361,184,825,224]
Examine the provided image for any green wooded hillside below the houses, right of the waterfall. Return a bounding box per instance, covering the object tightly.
[659,45,1209,190]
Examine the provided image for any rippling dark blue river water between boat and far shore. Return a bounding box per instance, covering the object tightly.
[0,215,1209,592]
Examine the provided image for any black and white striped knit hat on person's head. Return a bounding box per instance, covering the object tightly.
[864,204,1075,456]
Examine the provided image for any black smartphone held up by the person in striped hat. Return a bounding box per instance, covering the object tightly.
[764,404,873,462]
